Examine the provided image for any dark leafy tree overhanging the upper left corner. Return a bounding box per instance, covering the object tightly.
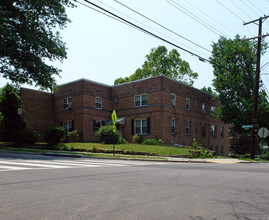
[0,0,73,88]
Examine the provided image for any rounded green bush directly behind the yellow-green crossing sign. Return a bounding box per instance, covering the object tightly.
[95,125,120,144]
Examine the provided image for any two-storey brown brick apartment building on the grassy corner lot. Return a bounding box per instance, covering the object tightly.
[21,76,229,155]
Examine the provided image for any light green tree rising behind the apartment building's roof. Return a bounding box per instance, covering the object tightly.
[114,46,198,85]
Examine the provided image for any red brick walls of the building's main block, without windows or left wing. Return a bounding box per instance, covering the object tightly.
[20,76,229,155]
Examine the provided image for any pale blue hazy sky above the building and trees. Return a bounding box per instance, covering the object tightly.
[0,0,269,90]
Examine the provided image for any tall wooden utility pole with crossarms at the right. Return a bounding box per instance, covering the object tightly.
[244,16,269,159]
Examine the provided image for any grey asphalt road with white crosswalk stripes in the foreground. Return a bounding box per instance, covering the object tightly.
[0,153,269,220]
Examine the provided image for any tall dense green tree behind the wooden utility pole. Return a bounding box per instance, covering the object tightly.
[210,35,269,141]
